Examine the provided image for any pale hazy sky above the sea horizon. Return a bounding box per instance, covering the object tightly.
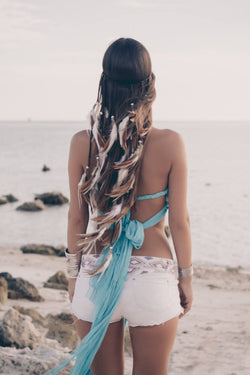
[0,0,250,121]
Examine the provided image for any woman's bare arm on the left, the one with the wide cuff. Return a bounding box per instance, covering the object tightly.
[67,131,89,301]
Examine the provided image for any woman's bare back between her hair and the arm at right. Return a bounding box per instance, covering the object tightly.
[131,127,177,258]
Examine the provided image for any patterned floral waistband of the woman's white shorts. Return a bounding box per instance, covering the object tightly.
[81,254,175,275]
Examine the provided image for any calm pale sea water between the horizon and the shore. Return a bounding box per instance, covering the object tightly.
[0,122,250,271]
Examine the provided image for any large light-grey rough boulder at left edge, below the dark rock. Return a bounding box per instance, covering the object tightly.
[0,308,44,349]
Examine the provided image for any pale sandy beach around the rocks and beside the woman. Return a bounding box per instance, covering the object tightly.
[0,247,250,375]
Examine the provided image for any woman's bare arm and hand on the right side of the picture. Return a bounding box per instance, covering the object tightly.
[168,132,193,314]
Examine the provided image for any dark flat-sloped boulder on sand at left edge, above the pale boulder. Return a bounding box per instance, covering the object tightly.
[0,272,44,302]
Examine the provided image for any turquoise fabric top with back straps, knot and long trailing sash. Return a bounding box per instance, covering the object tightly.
[44,188,168,375]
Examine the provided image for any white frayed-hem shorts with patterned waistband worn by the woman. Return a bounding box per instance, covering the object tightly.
[71,254,184,327]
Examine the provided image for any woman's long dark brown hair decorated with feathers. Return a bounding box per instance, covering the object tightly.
[77,38,156,258]
